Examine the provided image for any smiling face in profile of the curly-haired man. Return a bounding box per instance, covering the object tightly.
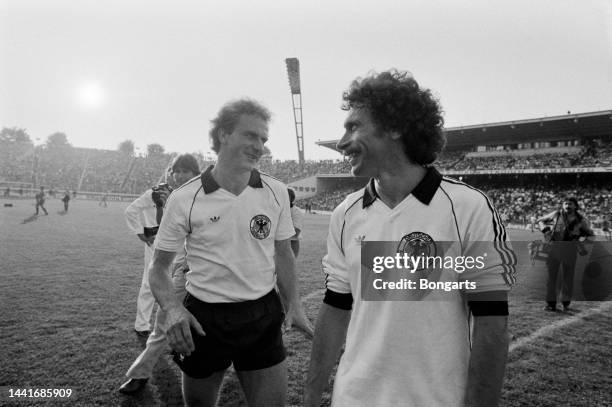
[336,108,393,177]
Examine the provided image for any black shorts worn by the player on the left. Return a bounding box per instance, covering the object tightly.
[174,290,285,379]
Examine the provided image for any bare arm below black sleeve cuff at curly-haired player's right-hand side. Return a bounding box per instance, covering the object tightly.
[466,316,508,407]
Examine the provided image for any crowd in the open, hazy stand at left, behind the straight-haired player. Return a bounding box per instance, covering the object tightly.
[0,136,350,194]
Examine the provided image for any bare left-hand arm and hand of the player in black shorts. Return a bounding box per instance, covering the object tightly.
[149,249,204,355]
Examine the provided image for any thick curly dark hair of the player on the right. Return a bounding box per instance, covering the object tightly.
[342,69,446,165]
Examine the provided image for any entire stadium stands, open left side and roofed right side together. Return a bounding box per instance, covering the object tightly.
[0,111,612,226]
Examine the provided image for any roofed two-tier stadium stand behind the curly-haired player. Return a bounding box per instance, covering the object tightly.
[298,110,612,227]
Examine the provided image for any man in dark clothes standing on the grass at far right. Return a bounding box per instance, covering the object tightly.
[538,197,594,312]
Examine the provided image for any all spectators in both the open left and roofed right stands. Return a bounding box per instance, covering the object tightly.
[0,131,612,230]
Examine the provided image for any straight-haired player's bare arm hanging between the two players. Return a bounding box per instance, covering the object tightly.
[274,239,314,337]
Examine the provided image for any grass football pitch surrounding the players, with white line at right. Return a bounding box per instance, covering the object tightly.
[0,200,612,406]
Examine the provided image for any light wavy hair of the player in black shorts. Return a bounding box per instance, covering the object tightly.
[209,98,272,153]
